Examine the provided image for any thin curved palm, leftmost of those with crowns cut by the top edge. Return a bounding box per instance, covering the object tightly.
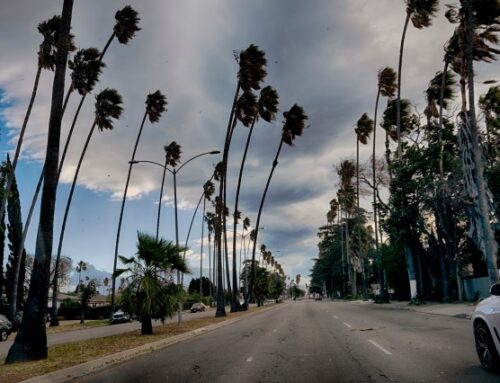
[396,0,439,159]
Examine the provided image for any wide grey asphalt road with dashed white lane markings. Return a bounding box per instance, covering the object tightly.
[76,301,500,383]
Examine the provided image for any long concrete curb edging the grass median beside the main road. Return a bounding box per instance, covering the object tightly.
[22,304,284,383]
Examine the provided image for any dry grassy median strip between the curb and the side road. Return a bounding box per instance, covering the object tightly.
[0,306,267,383]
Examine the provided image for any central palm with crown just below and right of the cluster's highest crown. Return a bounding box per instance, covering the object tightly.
[233,86,279,309]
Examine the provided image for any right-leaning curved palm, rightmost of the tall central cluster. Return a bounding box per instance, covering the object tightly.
[244,104,307,309]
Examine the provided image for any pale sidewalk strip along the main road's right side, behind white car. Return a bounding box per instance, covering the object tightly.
[353,301,476,319]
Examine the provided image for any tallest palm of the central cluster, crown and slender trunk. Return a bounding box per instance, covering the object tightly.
[215,44,267,317]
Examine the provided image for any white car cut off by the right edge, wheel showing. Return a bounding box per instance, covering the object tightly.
[472,283,500,372]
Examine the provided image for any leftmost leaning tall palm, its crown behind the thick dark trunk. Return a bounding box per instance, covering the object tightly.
[0,15,76,225]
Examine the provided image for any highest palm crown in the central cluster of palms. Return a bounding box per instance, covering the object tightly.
[238,44,267,91]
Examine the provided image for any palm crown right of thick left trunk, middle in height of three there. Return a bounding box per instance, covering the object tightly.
[68,48,106,96]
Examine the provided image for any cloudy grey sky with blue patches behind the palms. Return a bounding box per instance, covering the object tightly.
[0,0,498,288]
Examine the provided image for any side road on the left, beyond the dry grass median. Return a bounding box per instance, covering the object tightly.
[0,309,215,357]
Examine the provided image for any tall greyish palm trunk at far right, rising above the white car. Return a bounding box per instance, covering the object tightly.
[465,0,498,284]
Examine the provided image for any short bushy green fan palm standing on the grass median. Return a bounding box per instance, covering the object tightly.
[113,233,189,335]
